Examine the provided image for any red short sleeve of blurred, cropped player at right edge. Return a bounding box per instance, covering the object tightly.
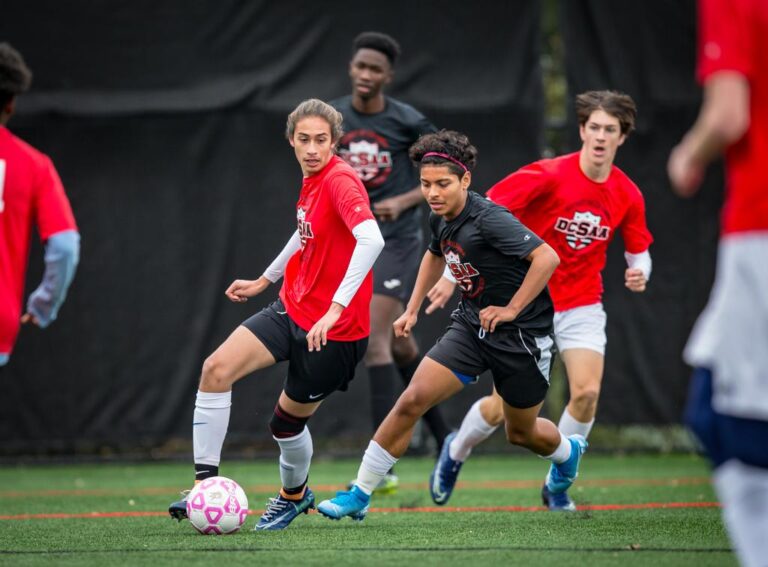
[697,0,752,83]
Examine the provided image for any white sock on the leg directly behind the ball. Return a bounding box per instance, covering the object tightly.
[192,390,232,466]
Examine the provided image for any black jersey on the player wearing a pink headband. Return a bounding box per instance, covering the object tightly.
[429,191,555,335]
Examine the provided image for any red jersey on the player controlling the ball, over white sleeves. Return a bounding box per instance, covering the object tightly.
[280,156,374,341]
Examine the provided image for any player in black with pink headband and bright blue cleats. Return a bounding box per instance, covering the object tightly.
[318,130,587,520]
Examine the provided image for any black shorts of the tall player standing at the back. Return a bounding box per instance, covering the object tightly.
[373,233,425,303]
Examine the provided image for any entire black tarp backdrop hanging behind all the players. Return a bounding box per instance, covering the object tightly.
[0,0,721,454]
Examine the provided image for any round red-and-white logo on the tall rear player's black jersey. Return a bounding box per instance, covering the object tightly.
[339,130,392,189]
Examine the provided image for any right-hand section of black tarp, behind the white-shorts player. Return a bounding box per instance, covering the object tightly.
[560,0,723,423]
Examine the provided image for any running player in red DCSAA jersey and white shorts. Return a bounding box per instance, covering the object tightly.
[428,91,652,511]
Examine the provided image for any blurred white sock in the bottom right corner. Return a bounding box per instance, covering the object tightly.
[713,460,768,567]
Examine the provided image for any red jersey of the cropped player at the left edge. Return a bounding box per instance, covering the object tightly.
[0,126,77,354]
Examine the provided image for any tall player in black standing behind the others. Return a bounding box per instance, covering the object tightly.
[331,32,449,492]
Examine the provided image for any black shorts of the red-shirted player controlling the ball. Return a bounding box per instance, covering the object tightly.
[243,300,368,404]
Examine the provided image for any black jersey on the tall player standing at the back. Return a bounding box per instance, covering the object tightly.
[331,95,437,238]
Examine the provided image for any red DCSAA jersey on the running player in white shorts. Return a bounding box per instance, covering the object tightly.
[487,152,653,311]
